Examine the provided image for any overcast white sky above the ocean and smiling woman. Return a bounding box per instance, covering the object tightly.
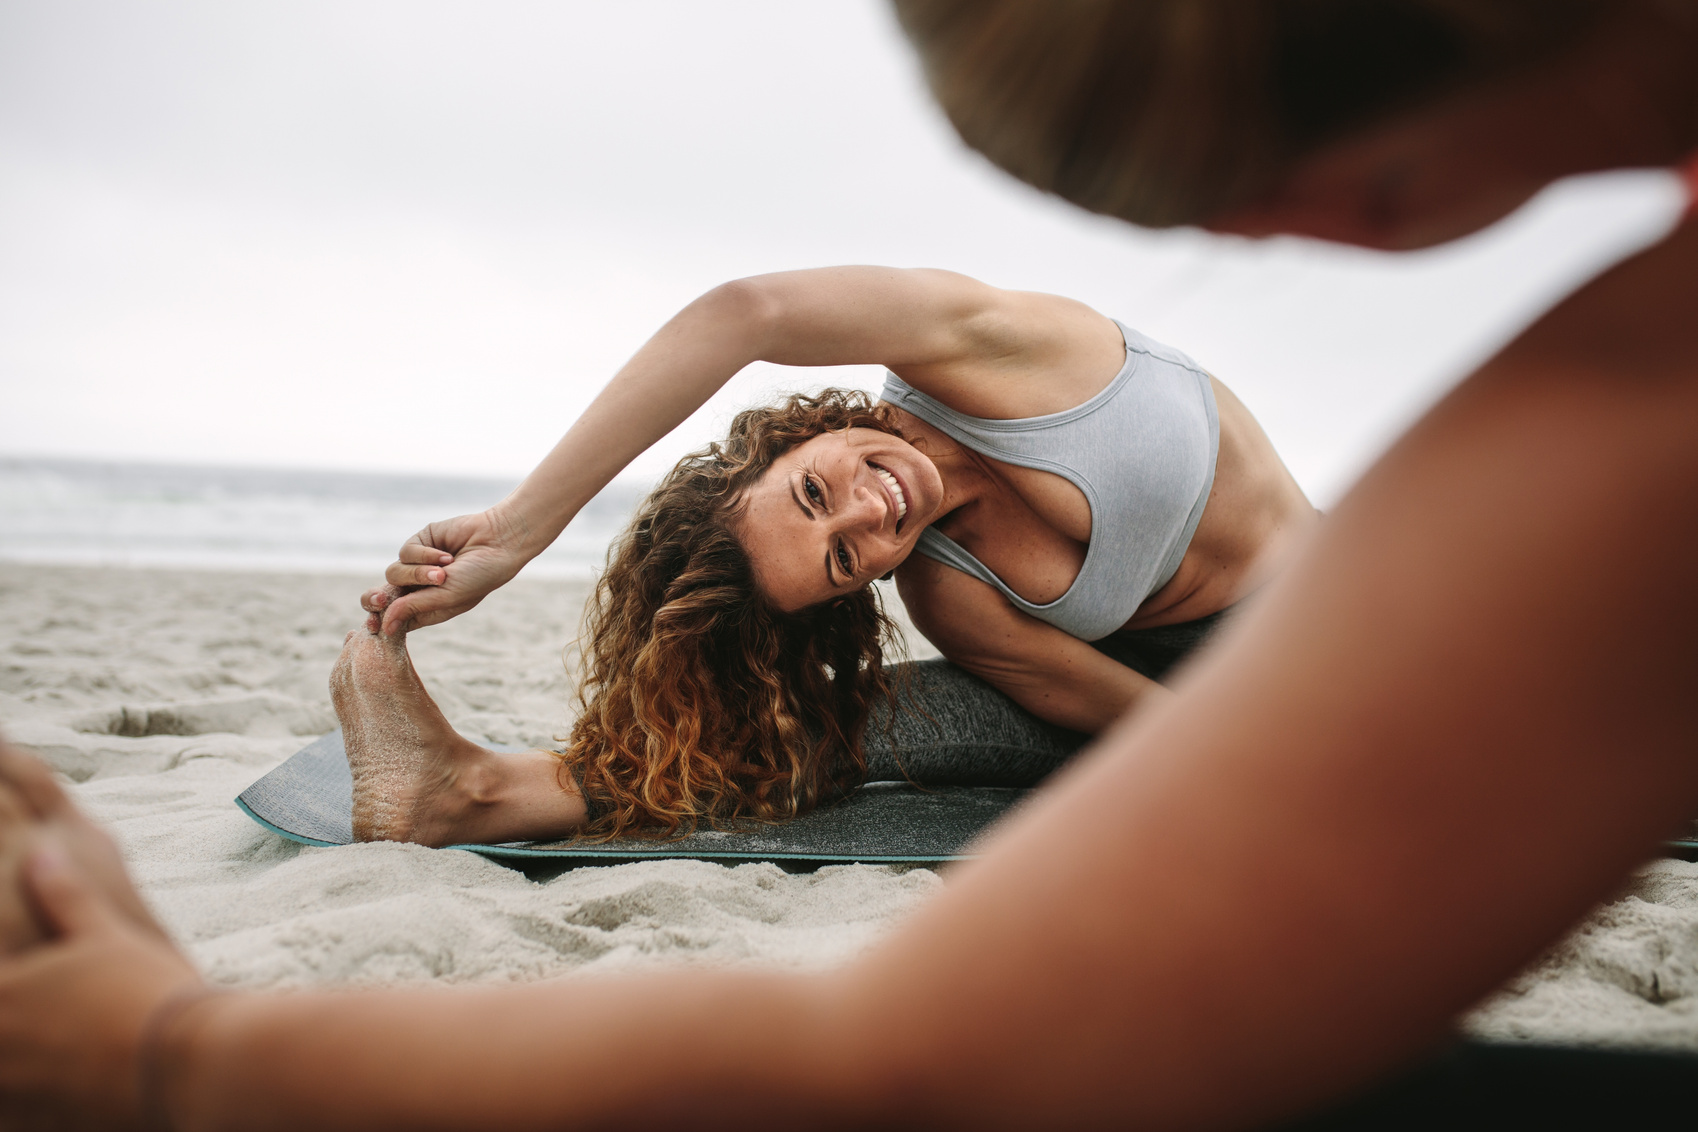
[0,0,1681,504]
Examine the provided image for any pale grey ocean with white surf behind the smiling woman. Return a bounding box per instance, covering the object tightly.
[0,457,647,579]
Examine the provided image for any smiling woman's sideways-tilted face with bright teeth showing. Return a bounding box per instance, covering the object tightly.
[740,428,944,613]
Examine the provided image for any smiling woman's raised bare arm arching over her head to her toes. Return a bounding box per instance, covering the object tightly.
[367,266,1117,631]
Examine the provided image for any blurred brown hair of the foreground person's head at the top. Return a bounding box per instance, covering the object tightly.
[895,0,1606,227]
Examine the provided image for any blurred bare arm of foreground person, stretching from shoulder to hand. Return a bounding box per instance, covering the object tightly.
[0,227,1698,1132]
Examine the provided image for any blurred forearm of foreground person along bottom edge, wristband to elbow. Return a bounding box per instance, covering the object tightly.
[158,971,868,1132]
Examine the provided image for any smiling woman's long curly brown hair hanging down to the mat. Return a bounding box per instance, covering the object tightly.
[565,390,895,837]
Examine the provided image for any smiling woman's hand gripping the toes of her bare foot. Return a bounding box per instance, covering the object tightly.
[360,507,535,633]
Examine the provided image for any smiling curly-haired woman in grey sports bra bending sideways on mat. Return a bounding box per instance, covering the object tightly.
[333,266,1314,843]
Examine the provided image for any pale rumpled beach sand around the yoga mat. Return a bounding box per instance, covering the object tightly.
[0,563,1698,1051]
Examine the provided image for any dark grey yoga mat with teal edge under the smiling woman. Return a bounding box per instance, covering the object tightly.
[236,731,1026,864]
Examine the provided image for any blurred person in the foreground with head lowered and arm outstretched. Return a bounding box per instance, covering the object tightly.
[0,0,1698,1129]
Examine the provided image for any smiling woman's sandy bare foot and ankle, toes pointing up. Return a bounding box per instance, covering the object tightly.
[329,618,584,845]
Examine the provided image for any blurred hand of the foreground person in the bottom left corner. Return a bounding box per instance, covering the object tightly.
[0,838,204,1130]
